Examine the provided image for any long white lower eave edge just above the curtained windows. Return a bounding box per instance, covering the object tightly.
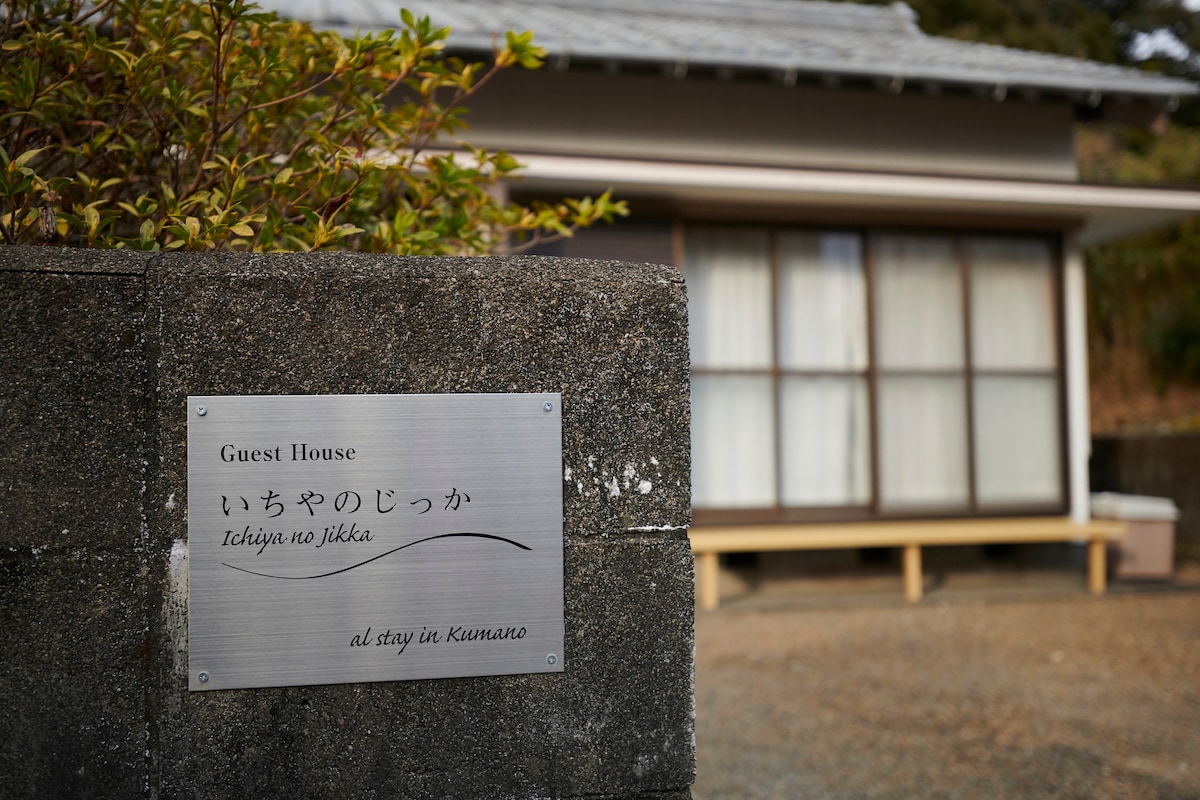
[511,152,1200,245]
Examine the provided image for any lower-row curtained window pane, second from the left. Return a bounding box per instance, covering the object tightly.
[781,377,871,506]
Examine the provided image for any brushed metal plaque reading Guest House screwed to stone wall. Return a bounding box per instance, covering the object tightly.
[187,393,564,690]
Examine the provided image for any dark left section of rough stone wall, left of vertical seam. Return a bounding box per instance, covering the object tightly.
[0,247,152,798]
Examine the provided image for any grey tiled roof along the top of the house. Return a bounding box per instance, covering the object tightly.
[257,0,1196,104]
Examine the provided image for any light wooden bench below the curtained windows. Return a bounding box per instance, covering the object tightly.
[688,517,1128,609]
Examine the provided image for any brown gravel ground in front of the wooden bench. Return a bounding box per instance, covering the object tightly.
[692,588,1200,800]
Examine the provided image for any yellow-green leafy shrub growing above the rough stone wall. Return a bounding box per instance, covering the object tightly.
[0,0,625,254]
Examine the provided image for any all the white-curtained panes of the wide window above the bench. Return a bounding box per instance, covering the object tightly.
[684,229,1062,511]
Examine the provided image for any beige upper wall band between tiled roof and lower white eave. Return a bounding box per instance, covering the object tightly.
[468,67,1076,181]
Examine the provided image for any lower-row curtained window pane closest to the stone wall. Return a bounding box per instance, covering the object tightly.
[691,375,775,509]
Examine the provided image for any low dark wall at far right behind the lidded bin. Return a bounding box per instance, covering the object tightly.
[1091,433,1200,561]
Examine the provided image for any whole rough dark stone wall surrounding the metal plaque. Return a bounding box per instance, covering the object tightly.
[0,248,695,799]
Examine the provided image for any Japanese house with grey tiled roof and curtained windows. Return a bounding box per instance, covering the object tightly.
[266,0,1200,597]
